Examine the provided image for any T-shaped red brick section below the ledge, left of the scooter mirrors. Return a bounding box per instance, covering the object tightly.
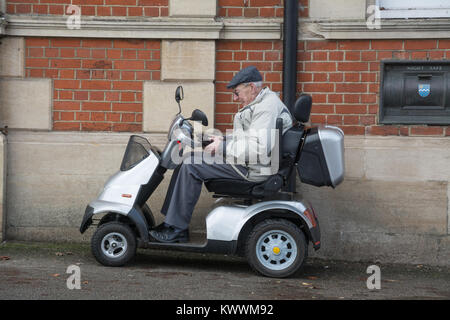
[25,38,160,131]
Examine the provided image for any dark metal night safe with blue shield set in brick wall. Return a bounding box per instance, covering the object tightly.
[379,60,450,125]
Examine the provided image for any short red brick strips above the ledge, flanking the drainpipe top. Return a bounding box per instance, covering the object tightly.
[217,0,309,18]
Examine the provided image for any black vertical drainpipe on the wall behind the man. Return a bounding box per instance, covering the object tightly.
[283,0,299,192]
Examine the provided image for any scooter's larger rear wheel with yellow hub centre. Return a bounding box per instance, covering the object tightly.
[245,219,308,278]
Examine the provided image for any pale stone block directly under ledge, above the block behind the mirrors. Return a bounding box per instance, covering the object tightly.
[161,40,216,81]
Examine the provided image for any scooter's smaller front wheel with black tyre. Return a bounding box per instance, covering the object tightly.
[91,222,136,267]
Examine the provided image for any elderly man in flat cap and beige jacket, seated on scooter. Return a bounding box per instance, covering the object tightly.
[150,66,292,243]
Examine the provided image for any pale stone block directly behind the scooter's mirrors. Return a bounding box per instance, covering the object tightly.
[143,81,214,132]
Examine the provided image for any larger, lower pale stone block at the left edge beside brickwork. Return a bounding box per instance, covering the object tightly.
[0,78,52,130]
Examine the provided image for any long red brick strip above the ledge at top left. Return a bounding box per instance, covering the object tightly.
[6,0,169,17]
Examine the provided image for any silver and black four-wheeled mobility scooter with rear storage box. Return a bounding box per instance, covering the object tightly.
[80,86,344,278]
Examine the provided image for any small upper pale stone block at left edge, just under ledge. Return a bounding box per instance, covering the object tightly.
[0,37,25,77]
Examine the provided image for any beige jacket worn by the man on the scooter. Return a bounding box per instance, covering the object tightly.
[226,87,292,181]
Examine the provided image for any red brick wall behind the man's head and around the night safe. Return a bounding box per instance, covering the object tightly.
[216,40,450,136]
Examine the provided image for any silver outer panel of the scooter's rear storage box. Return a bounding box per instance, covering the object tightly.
[318,126,345,187]
